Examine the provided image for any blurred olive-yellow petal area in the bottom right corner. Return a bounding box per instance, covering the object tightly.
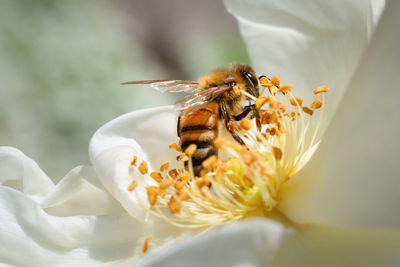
[268,225,400,267]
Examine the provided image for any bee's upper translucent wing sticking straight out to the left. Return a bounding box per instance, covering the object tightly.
[121,80,199,93]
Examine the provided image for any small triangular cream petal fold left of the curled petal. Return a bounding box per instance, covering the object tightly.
[40,166,125,216]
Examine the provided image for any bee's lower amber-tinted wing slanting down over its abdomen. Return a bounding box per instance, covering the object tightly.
[175,85,232,114]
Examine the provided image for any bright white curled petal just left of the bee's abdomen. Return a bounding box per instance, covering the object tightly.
[89,106,177,222]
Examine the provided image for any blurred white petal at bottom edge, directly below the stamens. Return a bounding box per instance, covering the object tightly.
[138,219,290,267]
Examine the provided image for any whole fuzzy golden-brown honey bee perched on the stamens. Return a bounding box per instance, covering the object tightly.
[122,64,260,176]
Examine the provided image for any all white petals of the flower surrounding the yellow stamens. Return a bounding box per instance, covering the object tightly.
[0,0,400,266]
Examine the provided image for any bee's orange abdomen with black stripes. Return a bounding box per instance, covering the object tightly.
[178,102,219,176]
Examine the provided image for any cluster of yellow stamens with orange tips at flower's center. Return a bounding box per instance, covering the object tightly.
[128,76,329,228]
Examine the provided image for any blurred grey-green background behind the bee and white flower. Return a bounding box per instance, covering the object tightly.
[0,0,249,181]
